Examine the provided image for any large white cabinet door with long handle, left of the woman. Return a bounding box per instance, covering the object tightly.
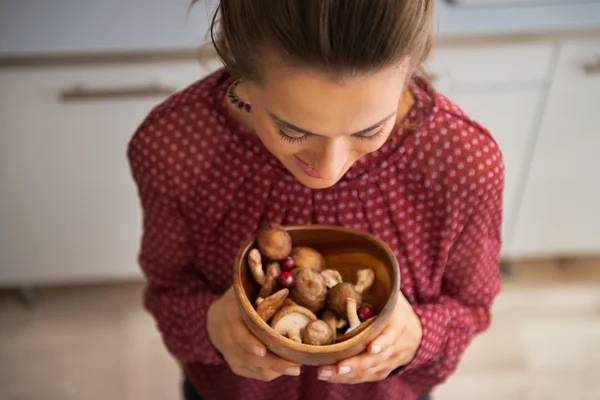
[0,61,216,285]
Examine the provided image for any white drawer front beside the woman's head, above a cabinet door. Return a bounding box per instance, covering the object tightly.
[425,42,554,89]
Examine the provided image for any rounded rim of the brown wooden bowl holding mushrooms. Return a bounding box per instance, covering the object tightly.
[233,224,401,354]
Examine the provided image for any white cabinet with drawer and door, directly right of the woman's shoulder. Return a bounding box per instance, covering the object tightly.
[428,42,555,259]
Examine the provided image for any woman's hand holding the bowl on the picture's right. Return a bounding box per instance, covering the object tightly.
[319,292,423,384]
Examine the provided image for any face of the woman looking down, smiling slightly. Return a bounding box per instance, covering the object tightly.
[246,67,406,189]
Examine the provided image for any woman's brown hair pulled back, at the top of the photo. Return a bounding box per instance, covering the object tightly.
[206,0,434,82]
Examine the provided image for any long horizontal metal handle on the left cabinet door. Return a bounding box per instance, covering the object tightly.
[59,83,177,102]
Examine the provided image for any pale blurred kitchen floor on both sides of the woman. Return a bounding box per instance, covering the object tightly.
[0,258,600,400]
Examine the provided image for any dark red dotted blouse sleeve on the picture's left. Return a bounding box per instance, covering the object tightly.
[128,122,224,364]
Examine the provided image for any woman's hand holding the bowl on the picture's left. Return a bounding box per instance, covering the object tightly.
[206,287,300,381]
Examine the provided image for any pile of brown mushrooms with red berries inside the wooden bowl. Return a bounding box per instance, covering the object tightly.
[248,224,375,346]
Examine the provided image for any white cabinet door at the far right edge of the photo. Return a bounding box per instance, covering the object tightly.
[511,39,600,256]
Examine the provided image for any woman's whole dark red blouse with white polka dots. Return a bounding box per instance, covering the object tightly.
[128,71,504,400]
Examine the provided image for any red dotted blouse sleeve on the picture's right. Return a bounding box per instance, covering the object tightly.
[397,132,504,390]
